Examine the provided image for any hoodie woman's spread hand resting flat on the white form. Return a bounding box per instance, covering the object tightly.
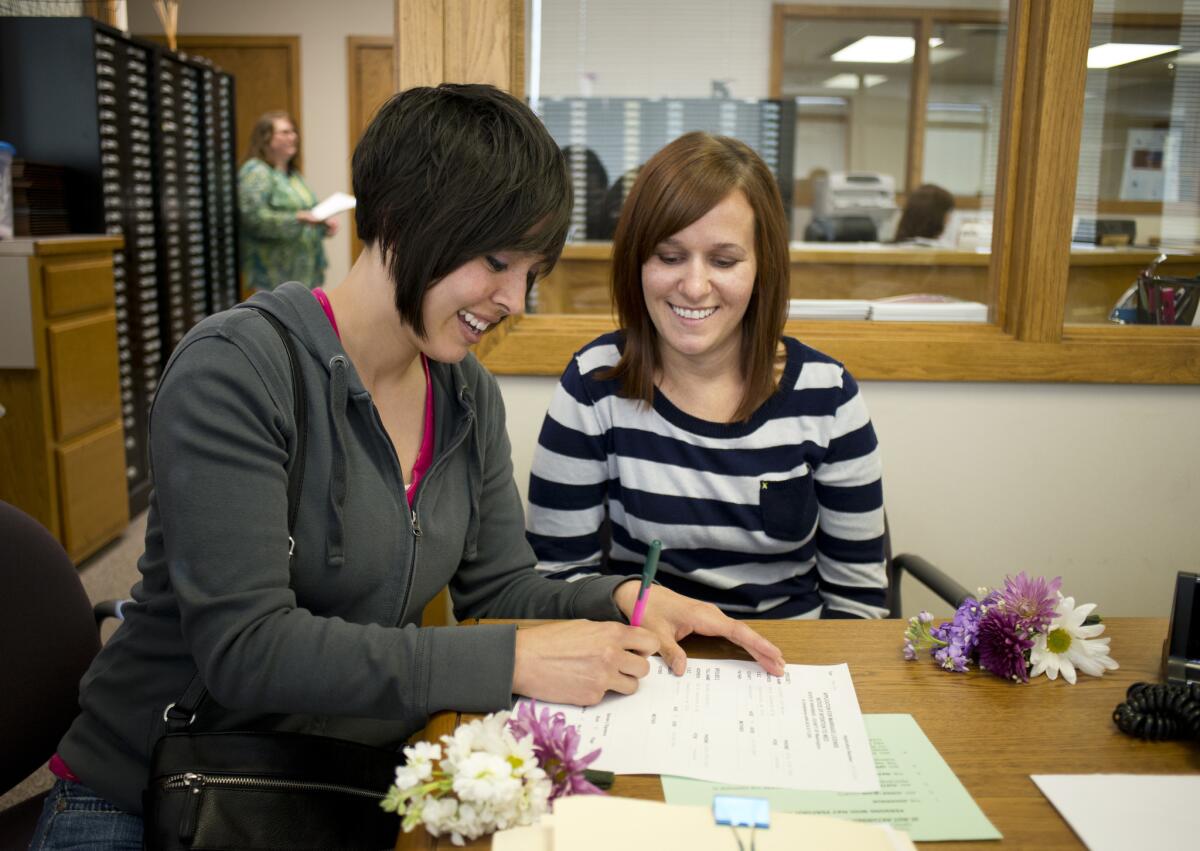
[613,580,785,677]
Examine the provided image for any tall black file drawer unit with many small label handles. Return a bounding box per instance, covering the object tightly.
[0,18,238,513]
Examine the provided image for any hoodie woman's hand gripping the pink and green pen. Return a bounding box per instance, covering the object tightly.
[512,621,659,706]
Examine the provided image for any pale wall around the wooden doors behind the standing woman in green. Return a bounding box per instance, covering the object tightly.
[128,0,395,286]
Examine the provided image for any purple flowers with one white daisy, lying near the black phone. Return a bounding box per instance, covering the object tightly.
[904,571,1117,684]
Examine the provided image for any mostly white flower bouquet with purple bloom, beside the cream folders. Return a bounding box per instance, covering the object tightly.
[380,702,602,845]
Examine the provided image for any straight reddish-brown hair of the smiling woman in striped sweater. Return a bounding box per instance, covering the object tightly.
[609,131,791,420]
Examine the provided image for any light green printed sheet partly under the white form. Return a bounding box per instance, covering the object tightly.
[662,715,1002,843]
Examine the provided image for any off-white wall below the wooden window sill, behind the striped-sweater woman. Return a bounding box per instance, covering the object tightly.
[500,376,1200,619]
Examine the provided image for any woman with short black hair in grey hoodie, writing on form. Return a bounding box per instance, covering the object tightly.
[35,85,782,849]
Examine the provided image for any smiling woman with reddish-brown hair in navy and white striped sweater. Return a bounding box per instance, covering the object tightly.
[527,132,887,618]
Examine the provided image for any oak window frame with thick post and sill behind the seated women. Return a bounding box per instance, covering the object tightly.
[405,0,1200,384]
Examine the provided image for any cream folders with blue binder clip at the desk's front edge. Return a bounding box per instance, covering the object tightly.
[492,795,914,851]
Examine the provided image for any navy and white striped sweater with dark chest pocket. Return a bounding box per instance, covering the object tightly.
[527,332,887,618]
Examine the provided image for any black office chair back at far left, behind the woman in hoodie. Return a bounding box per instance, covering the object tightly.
[0,502,119,851]
